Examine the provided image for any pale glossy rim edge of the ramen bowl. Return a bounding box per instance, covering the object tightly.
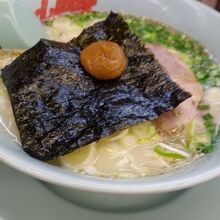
[0,0,220,194]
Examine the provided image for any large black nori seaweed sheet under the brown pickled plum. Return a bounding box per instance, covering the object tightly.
[2,13,190,160]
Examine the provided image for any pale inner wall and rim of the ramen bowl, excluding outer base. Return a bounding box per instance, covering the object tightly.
[0,0,220,193]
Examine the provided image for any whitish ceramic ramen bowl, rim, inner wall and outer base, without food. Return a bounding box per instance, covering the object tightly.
[0,0,220,211]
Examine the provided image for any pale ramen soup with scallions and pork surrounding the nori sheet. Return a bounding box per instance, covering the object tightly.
[0,12,220,178]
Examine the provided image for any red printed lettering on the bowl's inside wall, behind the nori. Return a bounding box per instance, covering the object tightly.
[35,0,97,20]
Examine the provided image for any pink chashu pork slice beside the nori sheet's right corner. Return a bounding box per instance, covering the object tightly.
[146,44,203,132]
